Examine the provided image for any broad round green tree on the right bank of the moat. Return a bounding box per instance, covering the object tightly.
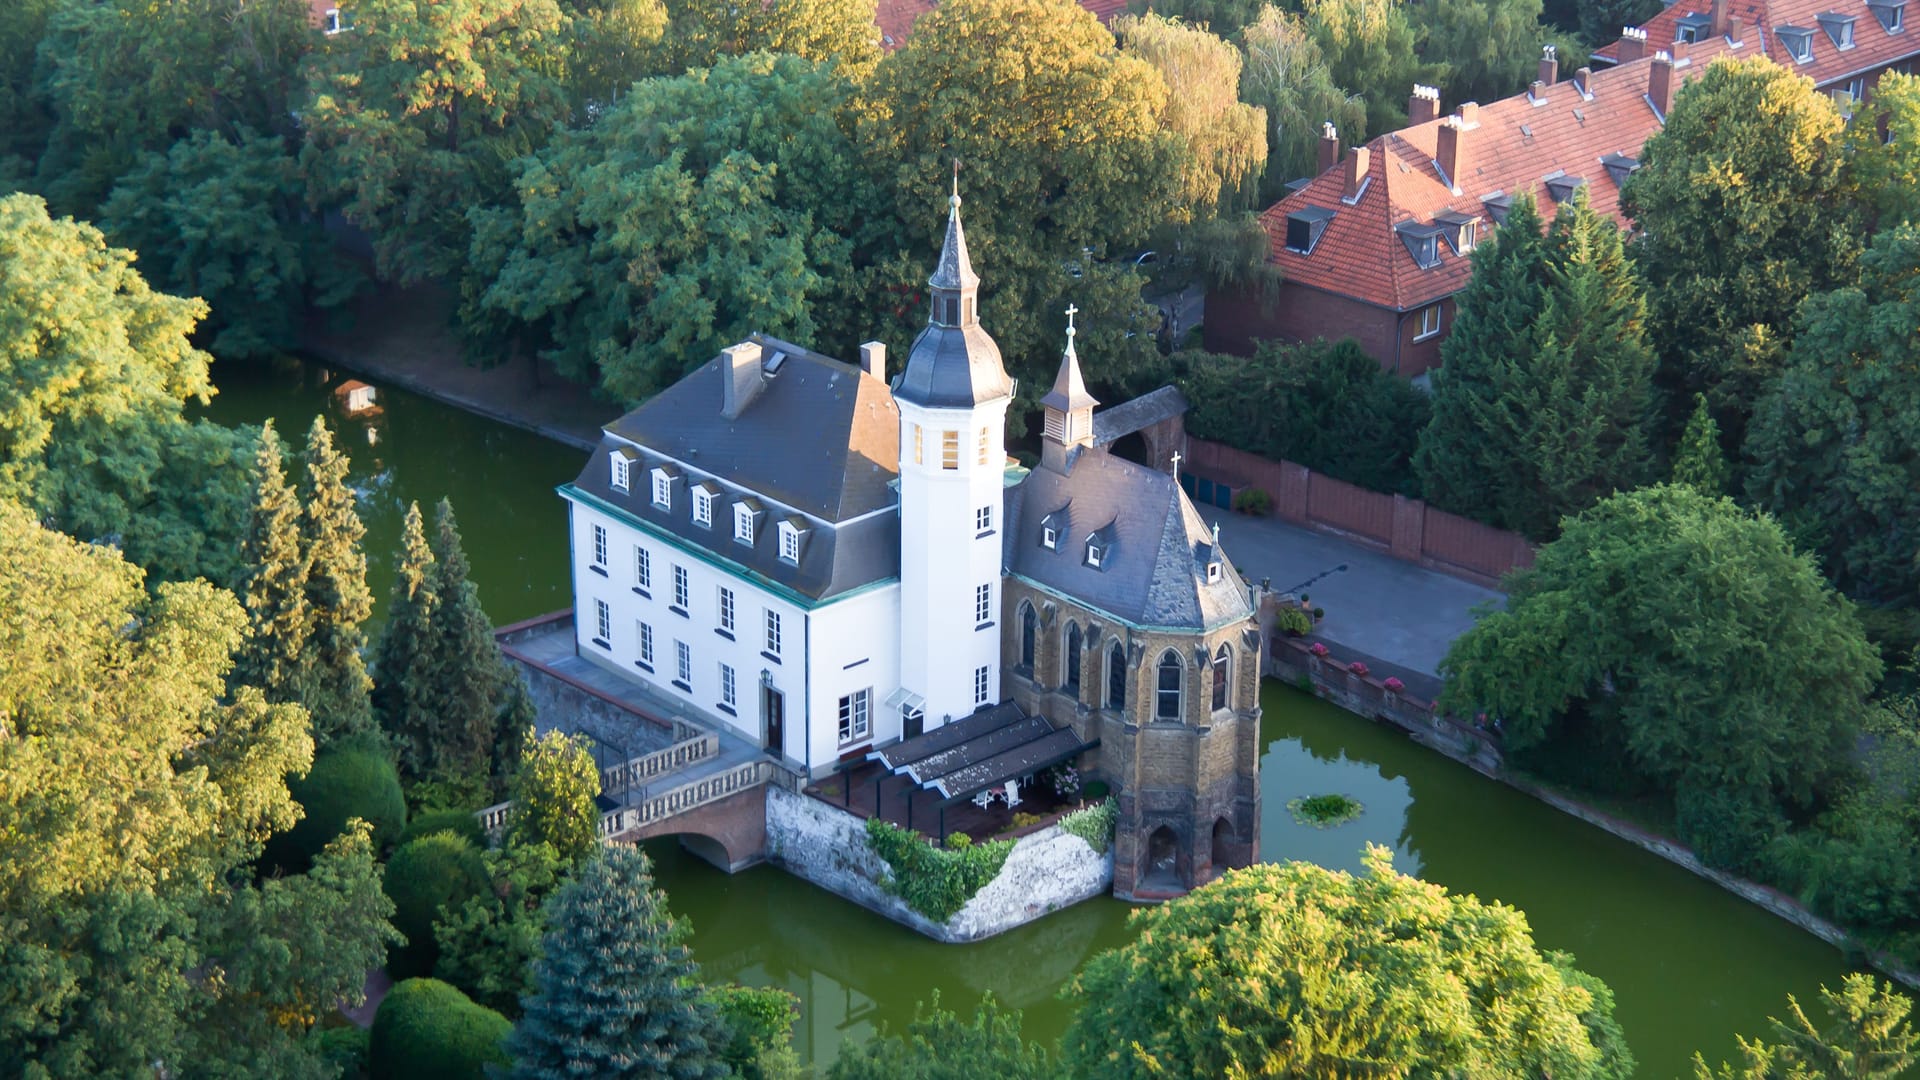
[1440,484,1880,869]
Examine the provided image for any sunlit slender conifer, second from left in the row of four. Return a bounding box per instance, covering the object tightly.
[300,417,372,744]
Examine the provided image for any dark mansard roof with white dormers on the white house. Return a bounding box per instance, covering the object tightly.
[572,334,900,600]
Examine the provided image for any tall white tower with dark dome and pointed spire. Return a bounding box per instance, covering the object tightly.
[893,179,1014,734]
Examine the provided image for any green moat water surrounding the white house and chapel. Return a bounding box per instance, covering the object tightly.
[205,363,1849,1078]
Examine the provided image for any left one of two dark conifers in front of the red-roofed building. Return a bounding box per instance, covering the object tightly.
[1413,196,1546,521]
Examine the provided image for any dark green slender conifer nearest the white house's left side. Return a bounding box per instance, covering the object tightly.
[420,500,507,778]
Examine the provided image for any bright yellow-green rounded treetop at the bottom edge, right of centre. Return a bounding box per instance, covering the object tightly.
[1062,846,1634,1078]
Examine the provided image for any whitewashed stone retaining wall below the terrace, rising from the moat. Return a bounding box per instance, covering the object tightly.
[766,786,1114,942]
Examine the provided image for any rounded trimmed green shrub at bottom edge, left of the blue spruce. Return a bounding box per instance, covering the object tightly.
[367,978,513,1080]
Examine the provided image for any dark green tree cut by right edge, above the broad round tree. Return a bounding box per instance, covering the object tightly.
[1745,225,1920,603]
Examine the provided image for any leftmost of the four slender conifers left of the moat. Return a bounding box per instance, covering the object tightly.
[232,421,313,703]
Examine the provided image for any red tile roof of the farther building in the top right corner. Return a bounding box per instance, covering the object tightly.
[1594,0,1920,88]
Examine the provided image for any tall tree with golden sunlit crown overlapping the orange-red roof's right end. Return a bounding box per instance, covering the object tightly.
[1620,56,1862,444]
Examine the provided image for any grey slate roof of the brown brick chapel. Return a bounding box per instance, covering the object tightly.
[1004,450,1252,630]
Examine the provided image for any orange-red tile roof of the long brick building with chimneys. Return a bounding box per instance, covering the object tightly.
[1261,50,1753,311]
